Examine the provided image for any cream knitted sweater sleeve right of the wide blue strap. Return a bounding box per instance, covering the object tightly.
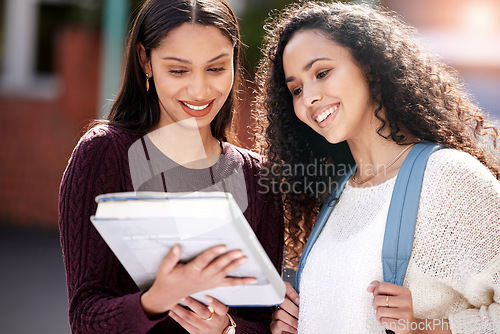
[415,150,500,334]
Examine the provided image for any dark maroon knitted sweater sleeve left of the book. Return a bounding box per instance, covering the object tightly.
[59,127,164,333]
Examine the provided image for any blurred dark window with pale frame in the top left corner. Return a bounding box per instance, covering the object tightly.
[0,0,84,99]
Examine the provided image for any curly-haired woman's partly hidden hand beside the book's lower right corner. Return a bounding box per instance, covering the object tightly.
[271,282,300,334]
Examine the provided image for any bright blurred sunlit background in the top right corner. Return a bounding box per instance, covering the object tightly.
[381,0,500,125]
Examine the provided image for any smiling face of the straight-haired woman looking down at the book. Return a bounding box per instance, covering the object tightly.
[139,23,234,133]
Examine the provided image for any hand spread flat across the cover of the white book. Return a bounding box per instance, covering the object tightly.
[141,245,256,317]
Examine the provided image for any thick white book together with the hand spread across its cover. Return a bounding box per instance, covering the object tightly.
[91,192,285,308]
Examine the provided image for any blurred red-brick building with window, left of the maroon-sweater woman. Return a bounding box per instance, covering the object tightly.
[0,0,101,227]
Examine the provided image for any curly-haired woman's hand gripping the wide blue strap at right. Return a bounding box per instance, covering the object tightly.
[367,281,419,334]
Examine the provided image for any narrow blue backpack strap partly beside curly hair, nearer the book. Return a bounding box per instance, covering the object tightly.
[294,167,356,293]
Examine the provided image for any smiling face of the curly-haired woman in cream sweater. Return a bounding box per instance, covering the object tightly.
[283,30,375,143]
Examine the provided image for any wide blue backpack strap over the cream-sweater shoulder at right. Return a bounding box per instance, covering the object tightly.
[382,142,444,285]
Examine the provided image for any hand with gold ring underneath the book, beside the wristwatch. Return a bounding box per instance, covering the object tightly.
[168,297,229,334]
